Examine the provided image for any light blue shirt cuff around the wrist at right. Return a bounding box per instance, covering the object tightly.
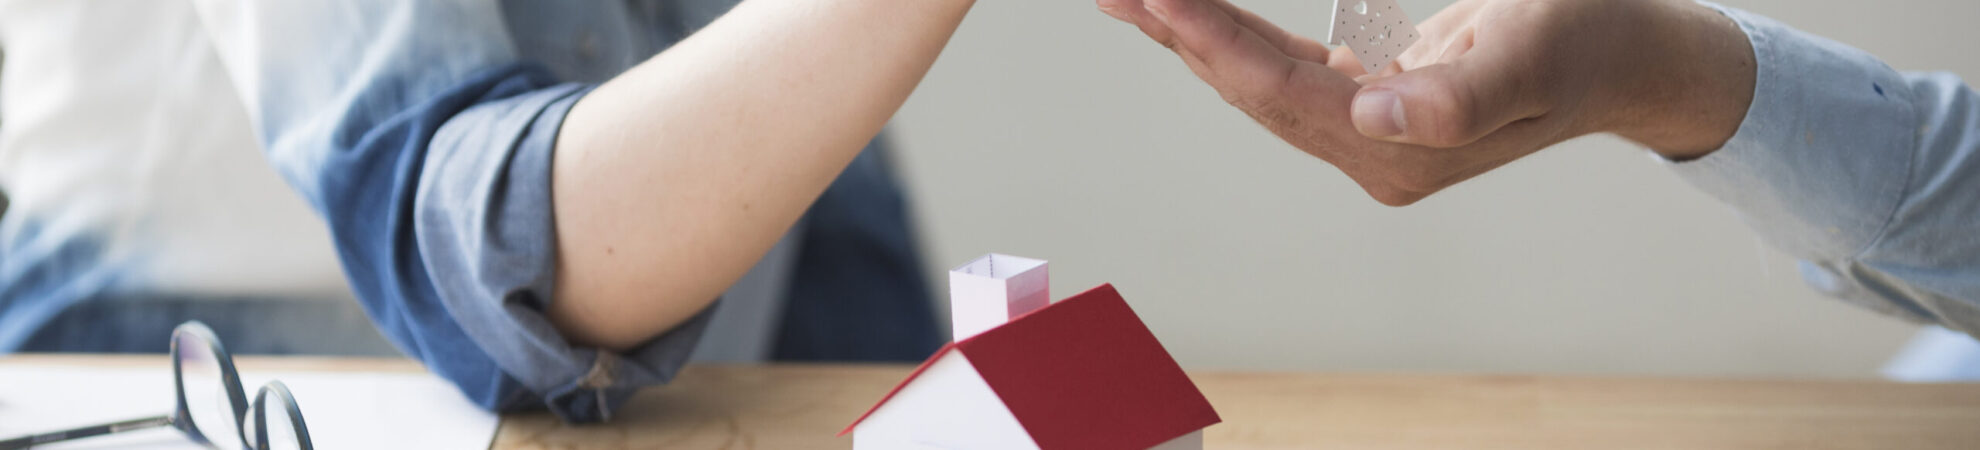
[1669,2,1917,260]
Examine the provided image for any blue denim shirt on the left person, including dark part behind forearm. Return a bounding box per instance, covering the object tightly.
[170,0,939,422]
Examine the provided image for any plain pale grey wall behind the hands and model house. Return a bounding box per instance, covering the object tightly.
[893,0,1980,377]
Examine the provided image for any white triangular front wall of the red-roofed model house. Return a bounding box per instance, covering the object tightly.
[853,351,1038,450]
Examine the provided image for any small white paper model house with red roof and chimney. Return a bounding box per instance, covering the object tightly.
[840,254,1222,450]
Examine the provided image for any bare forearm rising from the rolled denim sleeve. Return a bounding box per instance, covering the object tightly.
[548,0,974,349]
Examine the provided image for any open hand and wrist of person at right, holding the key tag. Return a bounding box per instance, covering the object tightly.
[1097,0,1754,206]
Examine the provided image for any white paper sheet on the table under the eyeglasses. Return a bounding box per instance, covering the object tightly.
[0,363,497,448]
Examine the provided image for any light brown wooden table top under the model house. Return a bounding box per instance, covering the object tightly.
[0,355,1980,448]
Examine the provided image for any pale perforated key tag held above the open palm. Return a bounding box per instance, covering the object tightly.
[1327,0,1418,73]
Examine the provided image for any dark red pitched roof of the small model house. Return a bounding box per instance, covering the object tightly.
[840,285,1224,450]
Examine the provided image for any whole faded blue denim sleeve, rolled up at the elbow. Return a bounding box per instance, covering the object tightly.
[187,0,709,422]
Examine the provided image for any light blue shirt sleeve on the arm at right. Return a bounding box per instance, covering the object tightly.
[1671,4,1980,335]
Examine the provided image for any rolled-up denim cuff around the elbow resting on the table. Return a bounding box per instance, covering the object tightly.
[414,72,713,422]
